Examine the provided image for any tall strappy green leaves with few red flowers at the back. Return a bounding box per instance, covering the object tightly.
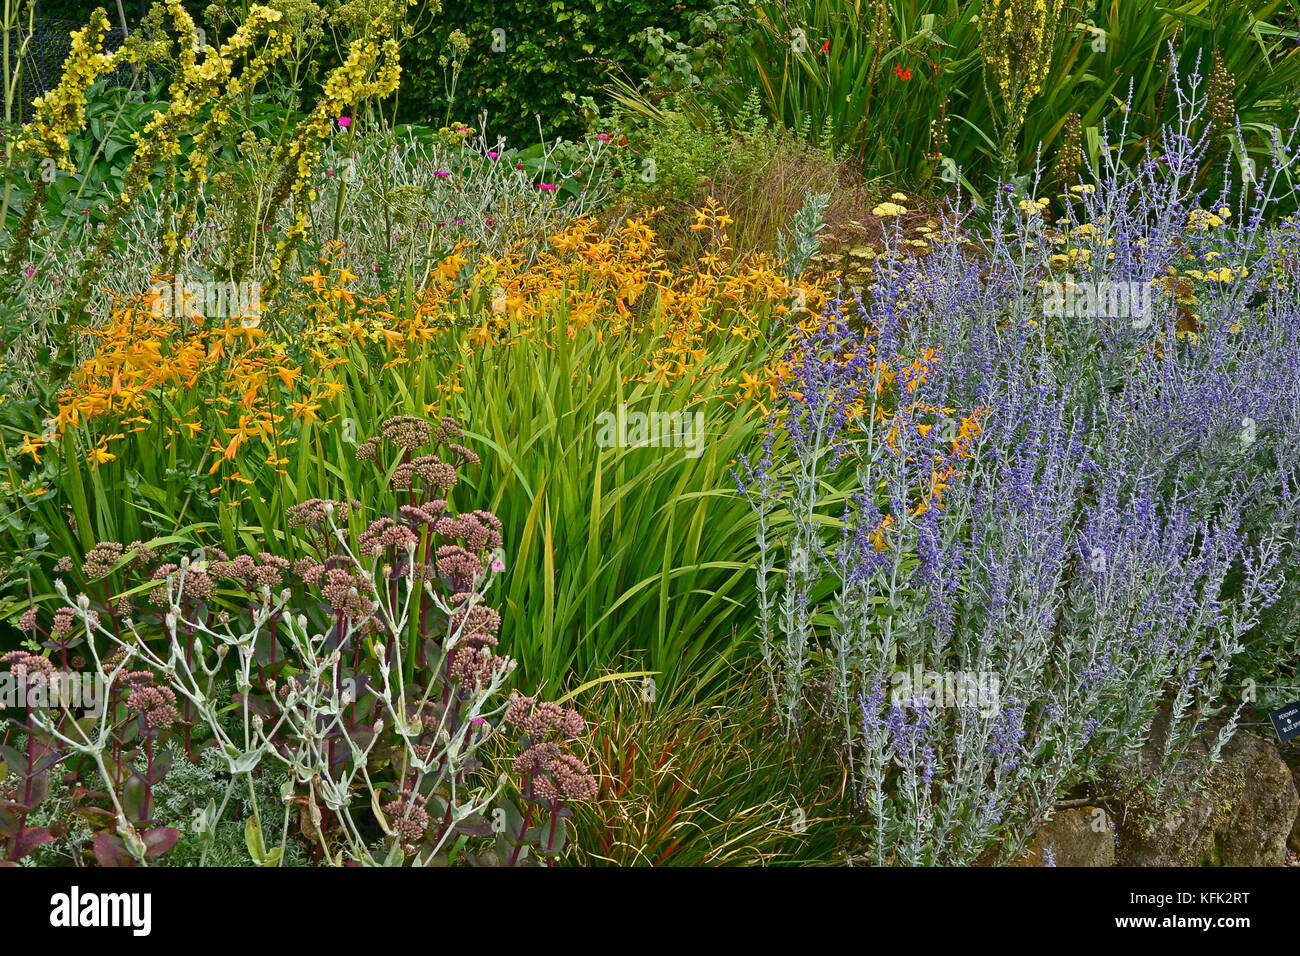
[612,0,1300,205]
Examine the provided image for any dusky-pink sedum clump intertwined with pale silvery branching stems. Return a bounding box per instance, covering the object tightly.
[8,416,597,866]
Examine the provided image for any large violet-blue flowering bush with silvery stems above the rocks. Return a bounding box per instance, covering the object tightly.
[737,61,1300,865]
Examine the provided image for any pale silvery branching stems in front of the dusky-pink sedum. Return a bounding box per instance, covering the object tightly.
[31,511,515,866]
